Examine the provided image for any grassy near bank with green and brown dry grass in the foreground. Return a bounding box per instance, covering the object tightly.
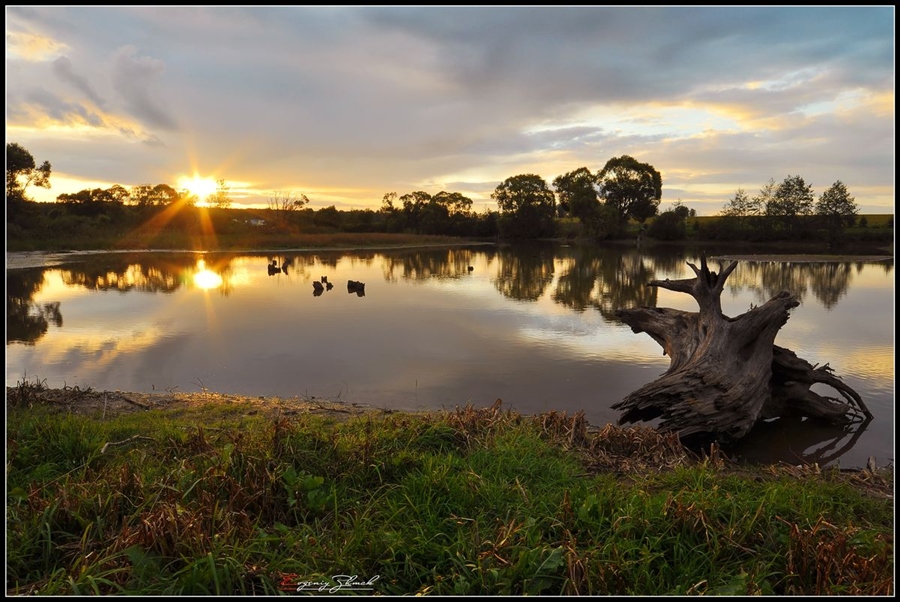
[7,383,894,595]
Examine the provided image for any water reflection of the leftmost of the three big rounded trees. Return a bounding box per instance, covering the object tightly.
[494,247,554,301]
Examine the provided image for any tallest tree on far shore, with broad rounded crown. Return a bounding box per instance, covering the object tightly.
[596,155,662,225]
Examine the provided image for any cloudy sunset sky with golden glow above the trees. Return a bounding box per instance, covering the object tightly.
[6,6,895,215]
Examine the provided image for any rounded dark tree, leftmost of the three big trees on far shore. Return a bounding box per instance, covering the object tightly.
[491,174,556,238]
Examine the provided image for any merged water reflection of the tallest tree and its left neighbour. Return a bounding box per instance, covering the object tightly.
[553,246,657,321]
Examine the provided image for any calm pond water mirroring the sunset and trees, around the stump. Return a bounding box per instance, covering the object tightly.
[6,245,894,467]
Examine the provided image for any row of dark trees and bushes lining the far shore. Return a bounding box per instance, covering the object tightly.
[6,142,884,243]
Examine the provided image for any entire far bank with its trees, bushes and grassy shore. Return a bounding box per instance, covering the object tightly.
[6,143,894,251]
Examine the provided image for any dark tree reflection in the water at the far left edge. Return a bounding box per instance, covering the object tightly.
[6,269,62,345]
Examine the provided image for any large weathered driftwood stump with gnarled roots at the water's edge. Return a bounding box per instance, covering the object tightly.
[612,255,872,441]
